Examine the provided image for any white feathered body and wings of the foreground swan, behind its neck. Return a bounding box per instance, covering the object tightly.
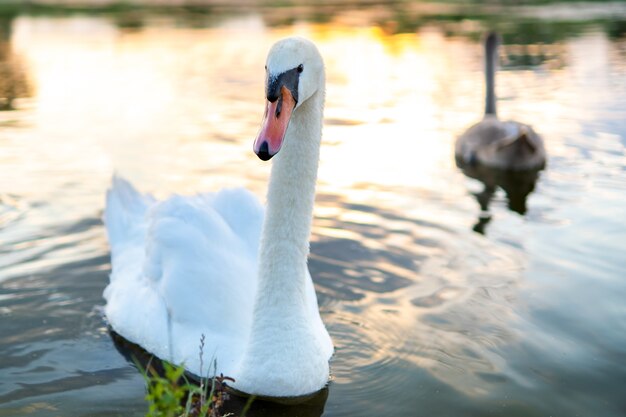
[104,177,263,375]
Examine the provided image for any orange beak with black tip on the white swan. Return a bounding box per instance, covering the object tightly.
[253,85,296,161]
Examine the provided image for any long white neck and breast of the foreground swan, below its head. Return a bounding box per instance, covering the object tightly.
[235,85,330,395]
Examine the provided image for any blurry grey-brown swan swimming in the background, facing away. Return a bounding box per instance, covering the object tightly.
[455,32,546,171]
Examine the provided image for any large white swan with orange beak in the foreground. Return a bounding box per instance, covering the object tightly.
[104,38,333,397]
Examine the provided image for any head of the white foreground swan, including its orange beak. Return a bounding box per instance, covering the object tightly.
[253,37,324,161]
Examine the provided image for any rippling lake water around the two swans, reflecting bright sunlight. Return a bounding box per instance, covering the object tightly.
[0,3,626,417]
